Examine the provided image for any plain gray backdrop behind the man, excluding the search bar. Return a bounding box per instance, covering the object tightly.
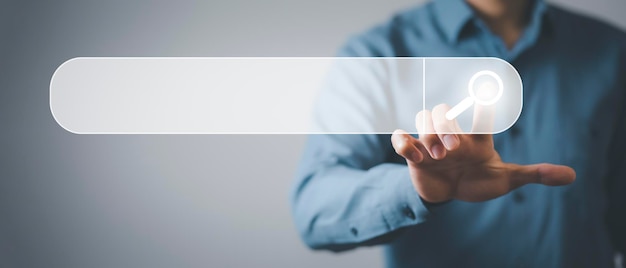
[0,0,626,267]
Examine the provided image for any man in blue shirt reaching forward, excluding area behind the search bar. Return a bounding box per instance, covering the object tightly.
[292,0,626,267]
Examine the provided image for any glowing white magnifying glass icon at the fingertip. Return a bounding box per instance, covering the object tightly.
[446,70,504,120]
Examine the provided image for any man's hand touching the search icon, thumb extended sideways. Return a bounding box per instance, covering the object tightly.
[391,105,576,203]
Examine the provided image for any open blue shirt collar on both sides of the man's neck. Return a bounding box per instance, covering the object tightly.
[433,0,547,42]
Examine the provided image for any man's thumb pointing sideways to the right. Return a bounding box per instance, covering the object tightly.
[510,163,576,190]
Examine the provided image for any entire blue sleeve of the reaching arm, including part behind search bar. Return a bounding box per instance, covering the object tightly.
[291,34,431,251]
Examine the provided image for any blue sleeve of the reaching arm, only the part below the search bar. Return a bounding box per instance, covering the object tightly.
[292,134,430,251]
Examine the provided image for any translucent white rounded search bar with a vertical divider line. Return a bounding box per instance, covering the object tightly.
[50,57,523,134]
